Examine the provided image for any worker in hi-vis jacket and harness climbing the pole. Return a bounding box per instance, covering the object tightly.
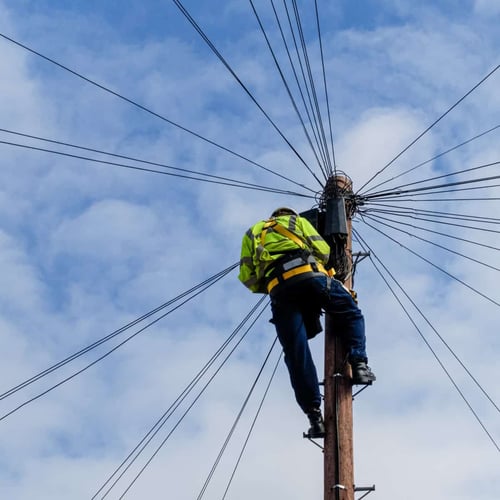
[238,207,375,438]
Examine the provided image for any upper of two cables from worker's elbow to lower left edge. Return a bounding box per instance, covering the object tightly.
[0,262,238,401]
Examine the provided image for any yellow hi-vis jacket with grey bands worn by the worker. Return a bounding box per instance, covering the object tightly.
[238,215,330,293]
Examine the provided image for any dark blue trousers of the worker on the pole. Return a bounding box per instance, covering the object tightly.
[271,276,367,413]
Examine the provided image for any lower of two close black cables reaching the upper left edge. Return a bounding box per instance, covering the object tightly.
[0,140,314,198]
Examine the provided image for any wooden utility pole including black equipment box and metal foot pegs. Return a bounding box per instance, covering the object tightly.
[322,175,375,500]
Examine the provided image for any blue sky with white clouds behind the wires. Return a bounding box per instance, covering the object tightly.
[0,0,500,500]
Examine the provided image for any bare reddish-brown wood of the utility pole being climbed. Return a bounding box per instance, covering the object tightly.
[324,176,354,500]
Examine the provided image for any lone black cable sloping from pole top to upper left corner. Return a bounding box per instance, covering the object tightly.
[0,33,307,189]
